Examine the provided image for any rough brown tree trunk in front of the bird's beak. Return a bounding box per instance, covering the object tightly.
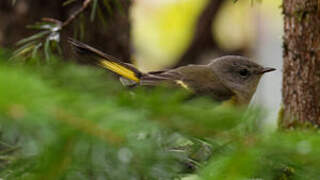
[280,0,320,128]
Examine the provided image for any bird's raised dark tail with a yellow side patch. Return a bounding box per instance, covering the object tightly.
[69,39,143,83]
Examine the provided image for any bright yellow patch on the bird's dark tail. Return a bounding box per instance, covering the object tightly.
[99,59,140,82]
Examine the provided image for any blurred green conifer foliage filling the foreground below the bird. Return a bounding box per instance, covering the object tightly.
[0,51,320,180]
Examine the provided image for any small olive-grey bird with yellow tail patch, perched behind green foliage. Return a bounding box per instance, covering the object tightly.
[69,38,276,106]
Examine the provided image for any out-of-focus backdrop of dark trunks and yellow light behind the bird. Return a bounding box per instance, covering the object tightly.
[0,0,282,127]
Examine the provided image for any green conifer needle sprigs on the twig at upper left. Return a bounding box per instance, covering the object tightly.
[12,0,123,62]
